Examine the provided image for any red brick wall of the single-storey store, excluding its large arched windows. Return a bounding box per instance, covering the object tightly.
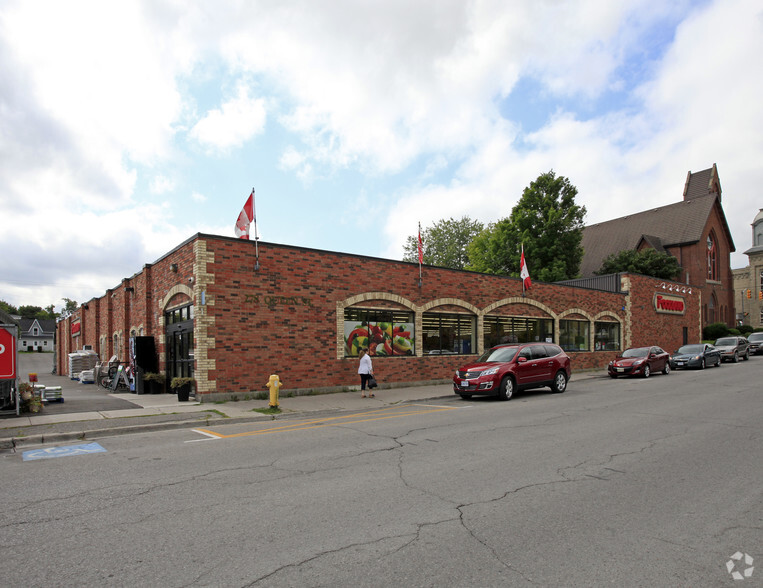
[58,235,701,399]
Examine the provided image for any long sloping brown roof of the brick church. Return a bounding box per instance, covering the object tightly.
[580,194,734,278]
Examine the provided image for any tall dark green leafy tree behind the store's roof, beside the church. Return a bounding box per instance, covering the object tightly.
[467,170,586,282]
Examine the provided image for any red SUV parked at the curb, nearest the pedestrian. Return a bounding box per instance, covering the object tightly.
[453,343,571,400]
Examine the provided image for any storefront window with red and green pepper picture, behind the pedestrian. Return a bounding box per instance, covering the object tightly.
[344,308,414,357]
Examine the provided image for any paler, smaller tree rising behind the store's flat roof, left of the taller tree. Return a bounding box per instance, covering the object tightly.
[403,216,483,269]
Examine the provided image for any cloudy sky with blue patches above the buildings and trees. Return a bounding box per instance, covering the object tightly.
[0,0,763,310]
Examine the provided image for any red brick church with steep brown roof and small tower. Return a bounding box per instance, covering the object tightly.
[580,164,736,327]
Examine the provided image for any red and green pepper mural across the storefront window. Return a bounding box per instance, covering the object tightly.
[344,313,414,357]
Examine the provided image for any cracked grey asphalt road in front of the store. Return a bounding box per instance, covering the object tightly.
[0,357,763,588]
